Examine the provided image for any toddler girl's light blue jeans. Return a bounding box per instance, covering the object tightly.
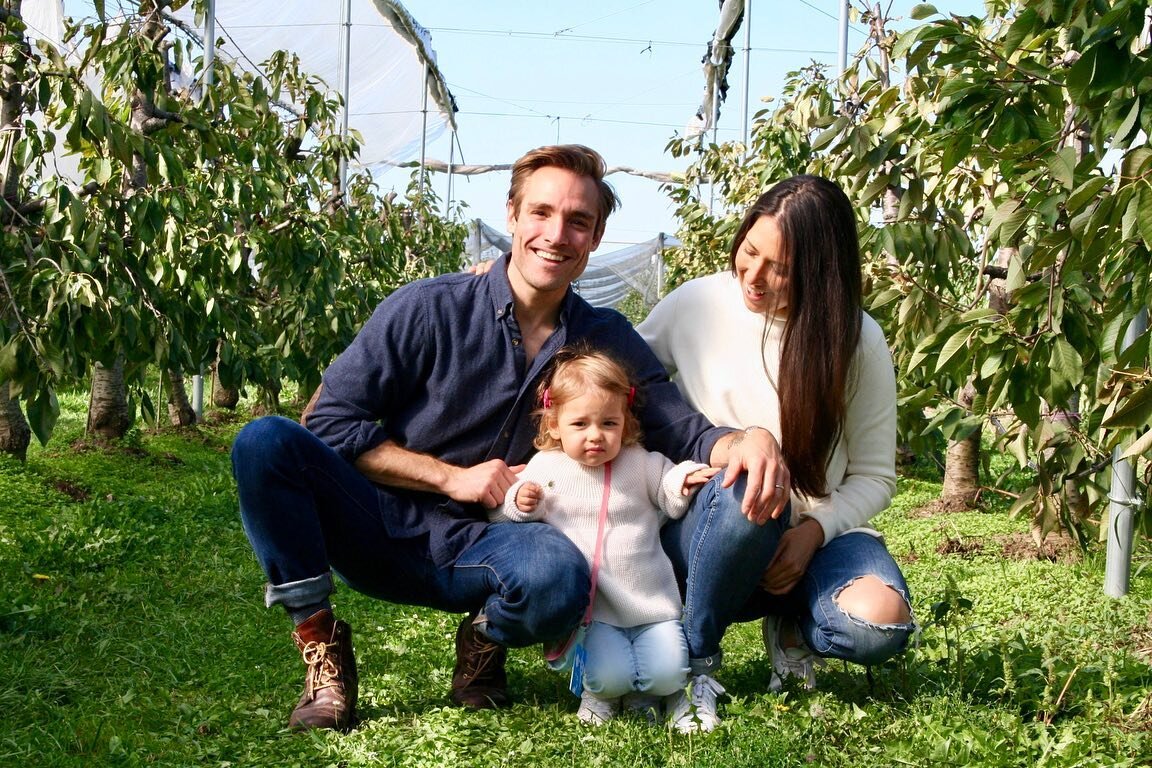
[584,621,688,699]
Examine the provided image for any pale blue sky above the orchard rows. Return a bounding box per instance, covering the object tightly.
[49,0,983,249]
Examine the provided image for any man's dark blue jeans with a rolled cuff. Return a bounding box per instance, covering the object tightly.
[232,416,589,647]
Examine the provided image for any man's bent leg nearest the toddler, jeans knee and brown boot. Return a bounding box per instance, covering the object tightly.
[452,523,589,709]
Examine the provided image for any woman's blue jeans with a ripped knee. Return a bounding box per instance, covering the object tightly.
[661,473,915,675]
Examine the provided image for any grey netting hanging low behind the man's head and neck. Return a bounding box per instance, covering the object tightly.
[464,219,680,307]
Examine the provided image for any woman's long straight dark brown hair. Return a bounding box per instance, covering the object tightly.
[728,175,863,497]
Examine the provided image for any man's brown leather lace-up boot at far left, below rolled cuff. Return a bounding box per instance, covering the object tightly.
[288,610,358,731]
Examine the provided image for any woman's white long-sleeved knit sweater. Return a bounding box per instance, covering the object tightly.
[637,272,896,542]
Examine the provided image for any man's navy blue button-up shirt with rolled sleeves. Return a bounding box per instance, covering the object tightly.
[308,257,729,565]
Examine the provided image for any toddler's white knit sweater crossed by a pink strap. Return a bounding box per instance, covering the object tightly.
[488,446,705,628]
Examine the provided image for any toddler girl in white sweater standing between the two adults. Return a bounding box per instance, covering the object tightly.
[491,349,719,724]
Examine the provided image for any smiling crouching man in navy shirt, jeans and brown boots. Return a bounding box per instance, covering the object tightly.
[233,145,788,729]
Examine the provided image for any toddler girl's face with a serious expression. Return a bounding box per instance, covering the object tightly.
[548,389,628,466]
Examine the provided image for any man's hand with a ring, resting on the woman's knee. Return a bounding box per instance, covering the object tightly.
[712,427,791,525]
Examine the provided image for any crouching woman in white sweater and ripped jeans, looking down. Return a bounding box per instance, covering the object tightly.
[638,175,915,714]
